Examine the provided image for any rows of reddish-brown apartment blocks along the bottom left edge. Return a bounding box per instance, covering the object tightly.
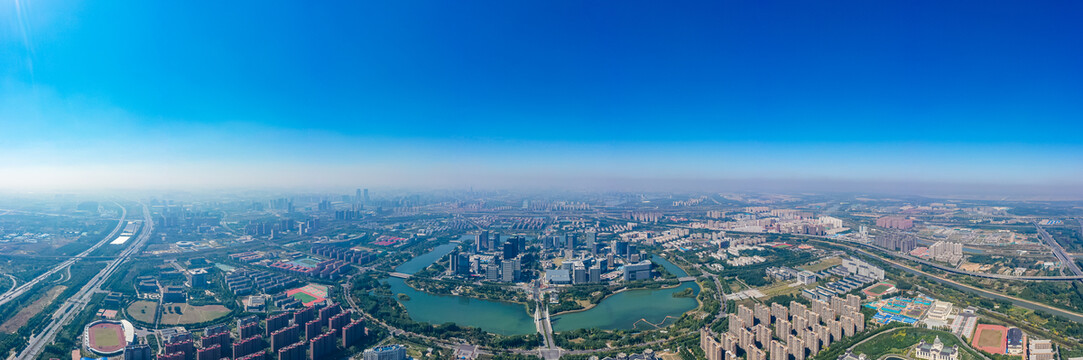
[148,304,367,360]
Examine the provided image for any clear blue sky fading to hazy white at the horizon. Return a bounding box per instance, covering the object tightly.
[0,0,1083,193]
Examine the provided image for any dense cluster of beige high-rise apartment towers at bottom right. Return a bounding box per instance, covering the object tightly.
[700,294,865,360]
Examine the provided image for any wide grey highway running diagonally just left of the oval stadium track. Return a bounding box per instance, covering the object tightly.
[16,204,154,360]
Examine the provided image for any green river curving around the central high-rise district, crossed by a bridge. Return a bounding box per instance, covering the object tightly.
[383,237,700,335]
